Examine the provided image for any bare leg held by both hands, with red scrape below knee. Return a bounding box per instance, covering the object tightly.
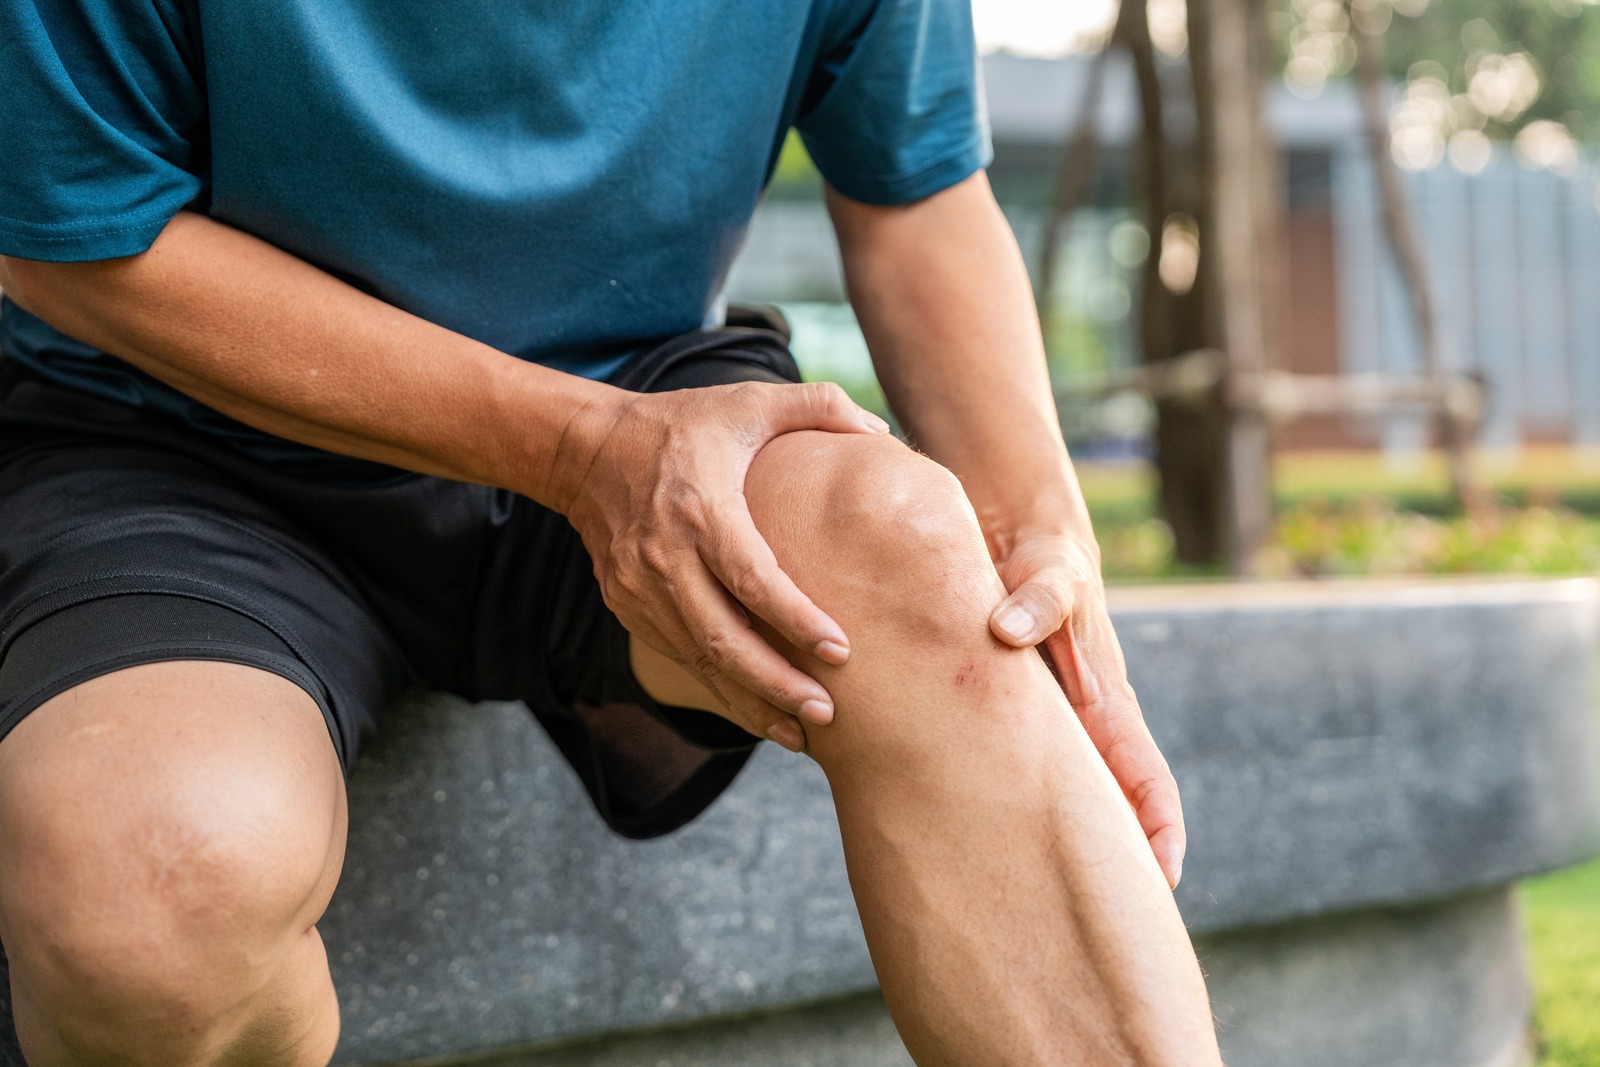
[635,432,1219,1067]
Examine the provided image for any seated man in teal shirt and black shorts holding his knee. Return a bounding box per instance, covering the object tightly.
[0,0,1218,1067]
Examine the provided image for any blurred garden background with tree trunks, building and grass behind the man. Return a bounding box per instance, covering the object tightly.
[728,0,1600,1065]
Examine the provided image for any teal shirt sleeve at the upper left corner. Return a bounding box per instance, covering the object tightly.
[0,0,205,262]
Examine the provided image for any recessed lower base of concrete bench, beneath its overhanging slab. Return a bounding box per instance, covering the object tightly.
[454,889,1528,1067]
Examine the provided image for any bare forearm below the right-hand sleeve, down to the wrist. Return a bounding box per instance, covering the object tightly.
[830,174,1093,553]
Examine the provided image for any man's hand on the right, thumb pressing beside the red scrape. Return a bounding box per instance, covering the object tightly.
[989,533,1186,888]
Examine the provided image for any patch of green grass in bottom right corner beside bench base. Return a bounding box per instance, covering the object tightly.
[1522,861,1600,1067]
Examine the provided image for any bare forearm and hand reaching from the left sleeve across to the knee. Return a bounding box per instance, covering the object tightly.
[0,211,888,747]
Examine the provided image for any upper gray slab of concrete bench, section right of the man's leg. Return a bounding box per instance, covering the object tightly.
[1117,579,1600,933]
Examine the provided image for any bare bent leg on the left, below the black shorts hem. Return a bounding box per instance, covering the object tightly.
[0,662,346,1067]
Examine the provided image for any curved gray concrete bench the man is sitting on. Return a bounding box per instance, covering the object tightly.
[0,579,1600,1067]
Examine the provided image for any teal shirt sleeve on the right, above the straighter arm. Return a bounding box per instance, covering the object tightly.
[795,0,994,205]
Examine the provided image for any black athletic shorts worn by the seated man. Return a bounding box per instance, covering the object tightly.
[0,326,800,837]
